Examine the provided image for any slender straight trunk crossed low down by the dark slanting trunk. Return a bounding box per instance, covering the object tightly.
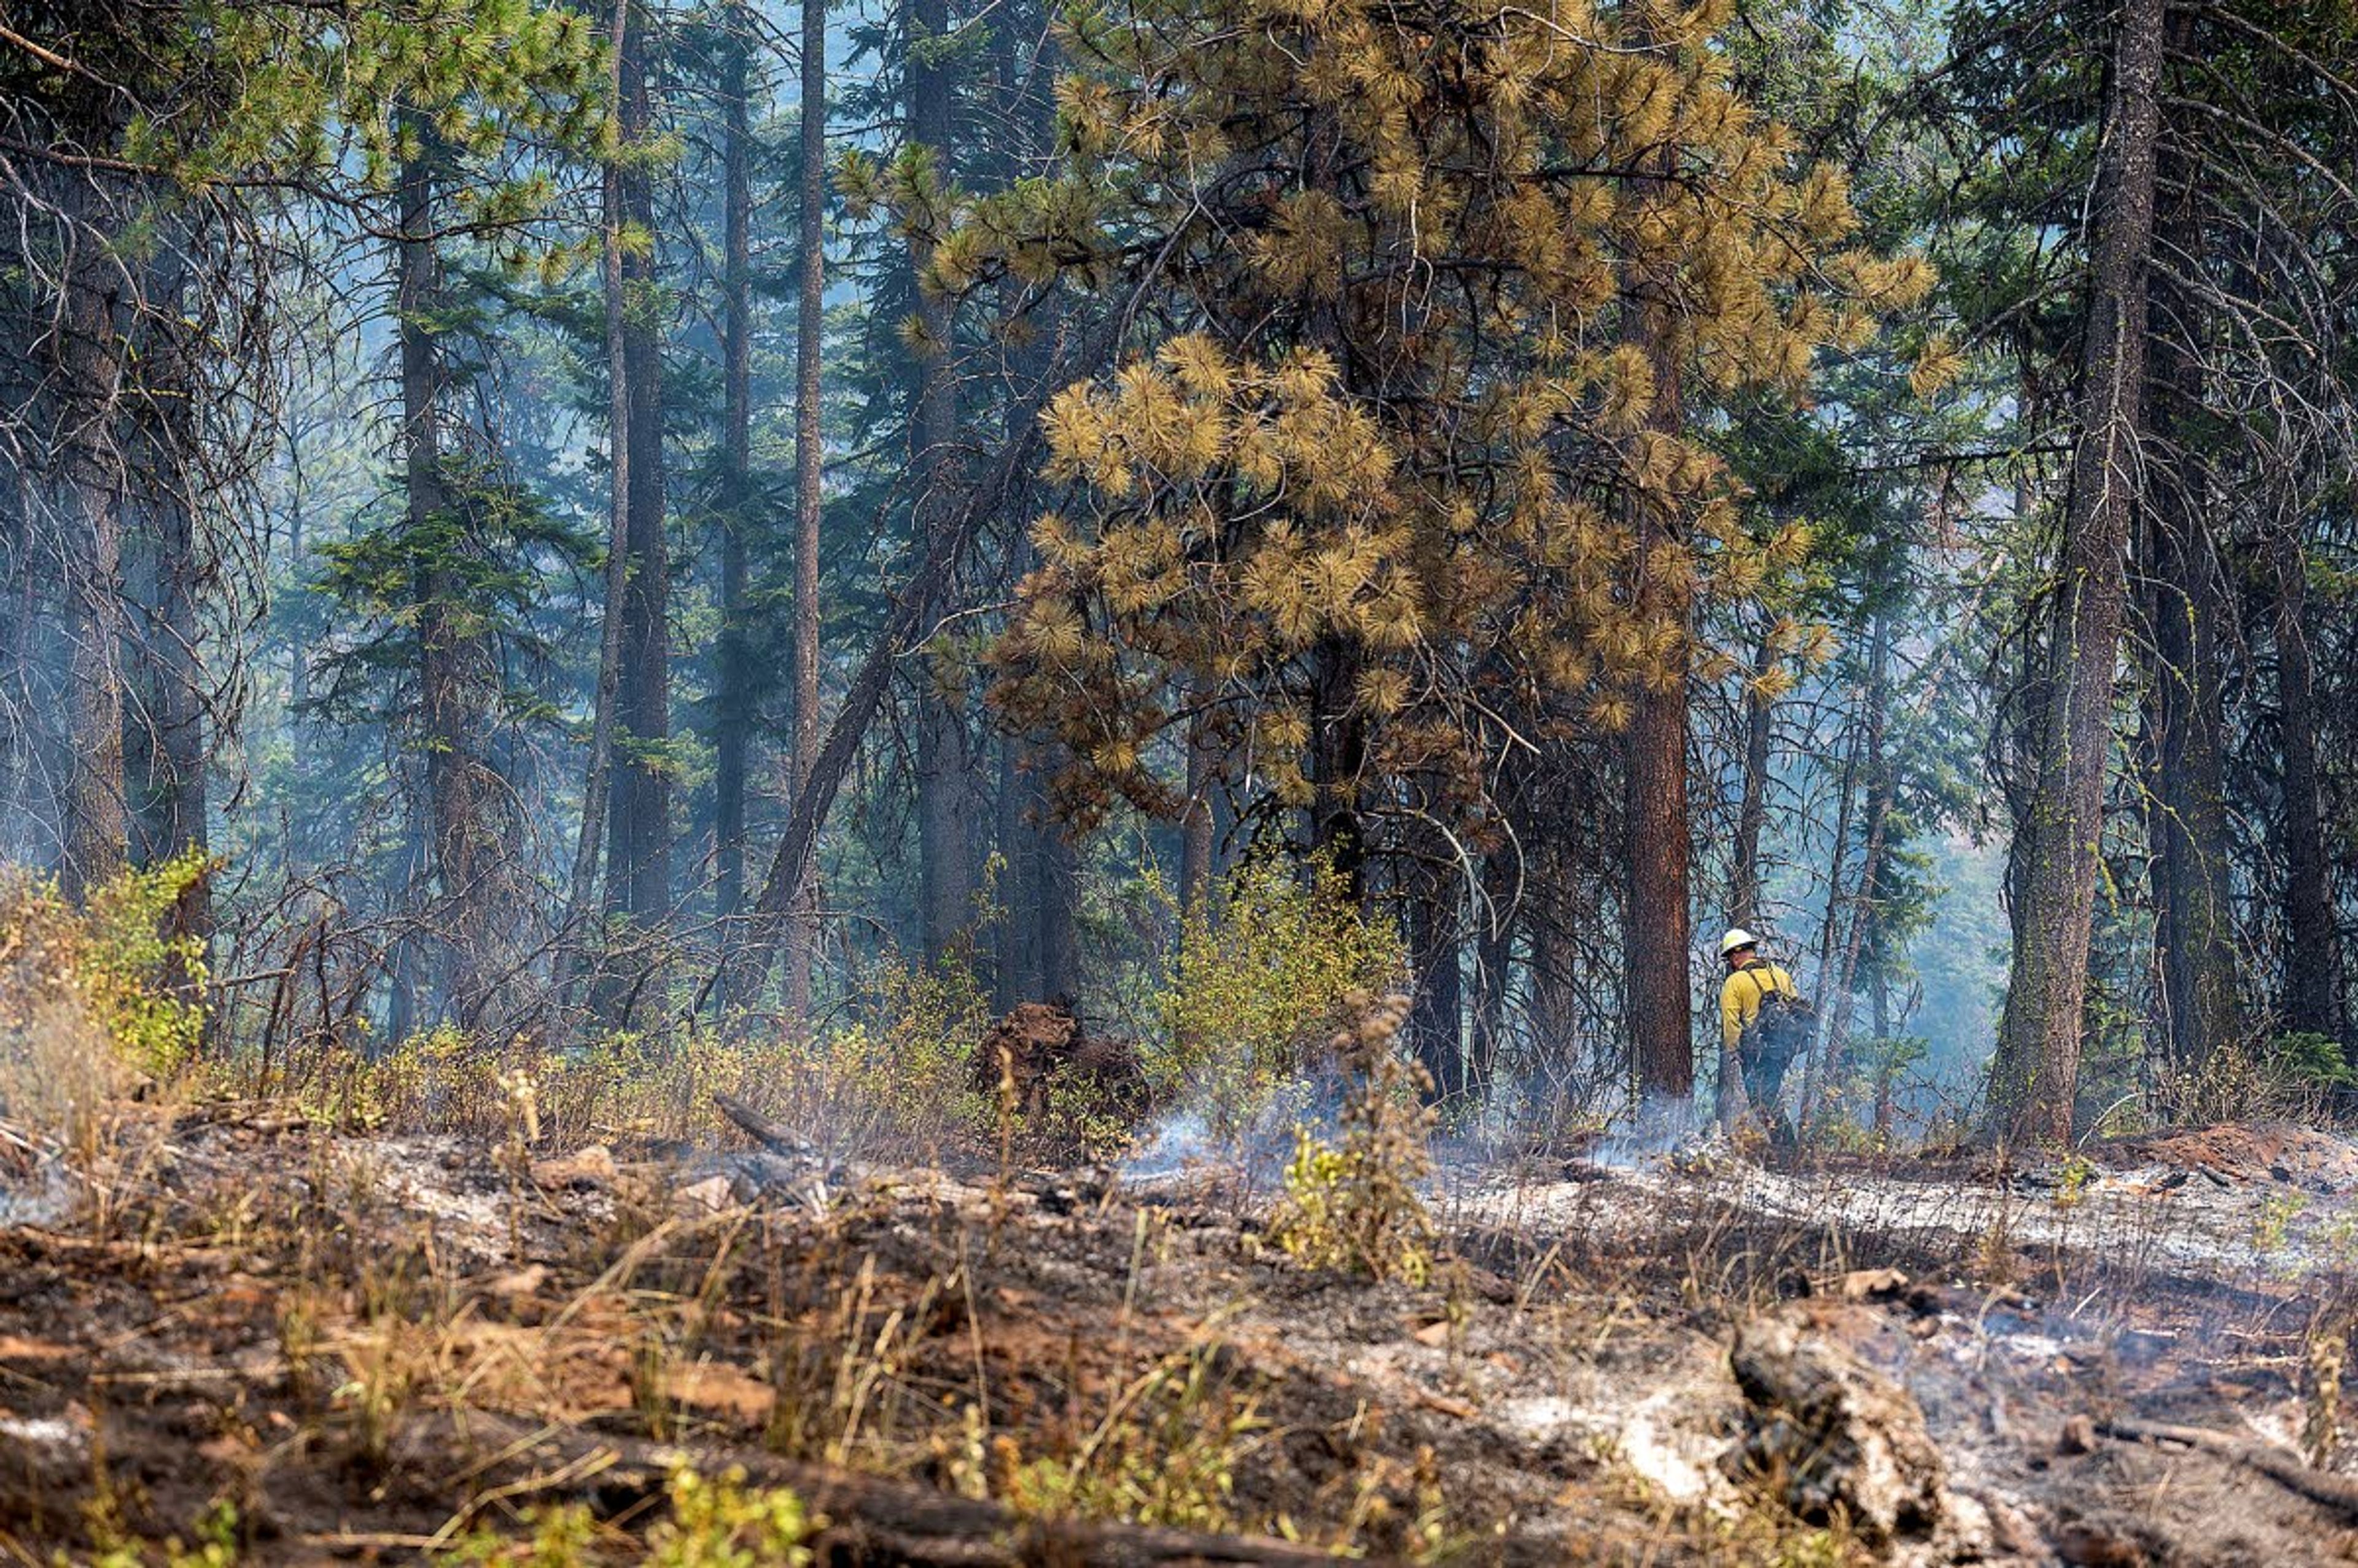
[785,0,828,1028]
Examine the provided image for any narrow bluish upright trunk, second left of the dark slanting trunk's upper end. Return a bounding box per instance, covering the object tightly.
[712,0,755,943]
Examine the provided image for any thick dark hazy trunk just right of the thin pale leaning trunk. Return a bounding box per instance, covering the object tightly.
[606,0,672,947]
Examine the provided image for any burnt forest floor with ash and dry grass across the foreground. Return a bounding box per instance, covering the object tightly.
[0,1103,2358,1566]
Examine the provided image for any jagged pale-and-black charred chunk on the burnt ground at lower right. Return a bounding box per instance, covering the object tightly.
[1721,1311,1948,1542]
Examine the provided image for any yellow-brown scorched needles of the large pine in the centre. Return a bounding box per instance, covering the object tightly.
[928,0,1931,821]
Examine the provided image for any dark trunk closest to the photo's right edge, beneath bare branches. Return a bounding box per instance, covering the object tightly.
[2268,533,2349,1040]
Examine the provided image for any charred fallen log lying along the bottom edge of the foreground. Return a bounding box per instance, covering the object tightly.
[396,1413,1333,1568]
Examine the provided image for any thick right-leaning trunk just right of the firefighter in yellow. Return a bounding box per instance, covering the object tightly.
[1985,0,2165,1144]
